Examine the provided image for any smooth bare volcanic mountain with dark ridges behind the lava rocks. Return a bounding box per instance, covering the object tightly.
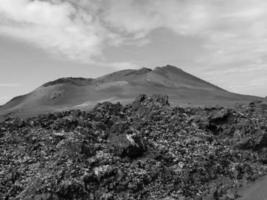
[0,65,261,117]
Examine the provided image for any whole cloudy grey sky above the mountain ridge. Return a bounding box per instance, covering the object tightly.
[0,0,267,104]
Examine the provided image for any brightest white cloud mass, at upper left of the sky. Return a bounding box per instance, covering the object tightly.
[0,0,109,61]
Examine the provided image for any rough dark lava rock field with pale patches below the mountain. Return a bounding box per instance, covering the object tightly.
[0,95,267,200]
